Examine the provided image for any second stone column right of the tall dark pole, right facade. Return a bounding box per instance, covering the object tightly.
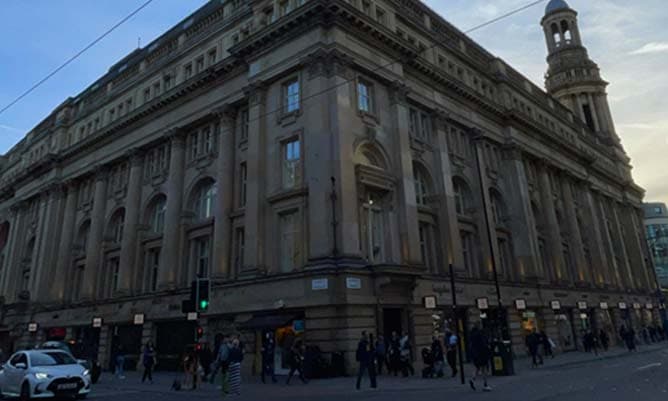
[538,164,567,282]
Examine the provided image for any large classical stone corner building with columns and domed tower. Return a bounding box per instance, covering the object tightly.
[0,0,657,369]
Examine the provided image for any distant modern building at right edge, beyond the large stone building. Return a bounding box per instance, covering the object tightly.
[643,202,668,290]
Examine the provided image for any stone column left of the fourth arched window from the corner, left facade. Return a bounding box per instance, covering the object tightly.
[51,181,77,302]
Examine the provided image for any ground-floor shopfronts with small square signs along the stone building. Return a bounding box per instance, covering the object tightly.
[0,269,659,376]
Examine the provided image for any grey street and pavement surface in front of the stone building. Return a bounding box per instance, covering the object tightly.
[89,343,668,401]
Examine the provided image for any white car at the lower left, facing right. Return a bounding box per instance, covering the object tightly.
[0,349,91,401]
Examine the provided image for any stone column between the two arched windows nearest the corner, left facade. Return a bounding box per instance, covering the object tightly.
[158,128,185,290]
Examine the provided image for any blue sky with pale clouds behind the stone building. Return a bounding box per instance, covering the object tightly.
[0,0,668,202]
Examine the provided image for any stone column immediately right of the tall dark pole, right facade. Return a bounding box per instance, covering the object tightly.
[502,141,542,282]
